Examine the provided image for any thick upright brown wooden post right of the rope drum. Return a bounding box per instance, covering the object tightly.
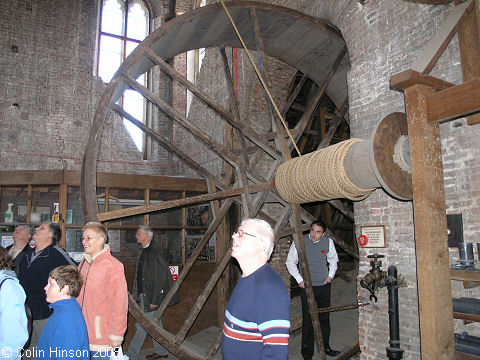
[404,85,455,360]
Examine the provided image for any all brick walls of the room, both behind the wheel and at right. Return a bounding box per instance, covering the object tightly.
[0,0,480,359]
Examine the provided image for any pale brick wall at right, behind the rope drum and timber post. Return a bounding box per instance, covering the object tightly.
[312,1,480,359]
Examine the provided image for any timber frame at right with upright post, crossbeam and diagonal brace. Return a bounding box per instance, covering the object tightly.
[390,0,480,359]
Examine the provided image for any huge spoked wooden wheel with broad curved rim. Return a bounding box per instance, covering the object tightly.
[81,1,356,359]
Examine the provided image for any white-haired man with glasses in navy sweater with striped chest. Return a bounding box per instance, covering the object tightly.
[222,219,290,360]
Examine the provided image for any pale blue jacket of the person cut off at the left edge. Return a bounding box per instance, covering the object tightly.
[0,269,28,360]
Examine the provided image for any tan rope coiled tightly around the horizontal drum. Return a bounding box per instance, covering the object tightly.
[275,138,374,204]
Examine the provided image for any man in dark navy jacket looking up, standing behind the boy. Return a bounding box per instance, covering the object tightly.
[18,222,76,359]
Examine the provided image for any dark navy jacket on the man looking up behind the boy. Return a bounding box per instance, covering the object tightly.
[18,244,76,320]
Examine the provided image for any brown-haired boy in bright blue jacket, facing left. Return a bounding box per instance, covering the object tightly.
[35,265,90,360]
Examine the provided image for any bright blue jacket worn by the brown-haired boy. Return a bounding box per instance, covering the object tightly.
[35,298,90,360]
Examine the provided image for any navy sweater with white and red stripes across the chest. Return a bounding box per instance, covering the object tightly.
[222,264,290,360]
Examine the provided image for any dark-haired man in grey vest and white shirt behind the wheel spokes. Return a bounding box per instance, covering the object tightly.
[286,221,340,360]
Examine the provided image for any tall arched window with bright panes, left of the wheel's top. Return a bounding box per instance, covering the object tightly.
[97,0,150,153]
